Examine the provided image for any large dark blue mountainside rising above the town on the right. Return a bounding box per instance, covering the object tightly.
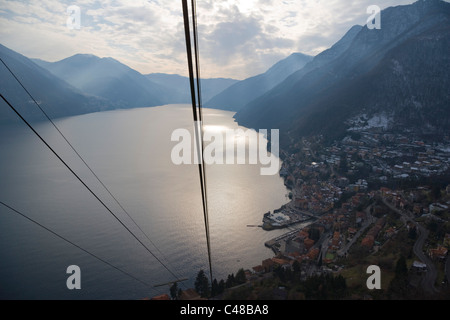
[235,0,450,142]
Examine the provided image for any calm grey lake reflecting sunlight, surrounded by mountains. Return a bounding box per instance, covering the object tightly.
[0,105,288,299]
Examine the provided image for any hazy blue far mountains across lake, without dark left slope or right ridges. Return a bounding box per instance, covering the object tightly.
[33,54,237,108]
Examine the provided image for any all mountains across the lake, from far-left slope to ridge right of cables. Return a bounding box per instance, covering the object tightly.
[0,39,312,118]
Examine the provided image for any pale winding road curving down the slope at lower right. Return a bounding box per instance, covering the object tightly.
[383,199,440,293]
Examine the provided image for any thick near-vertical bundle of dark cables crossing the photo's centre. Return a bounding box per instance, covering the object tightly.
[182,0,213,283]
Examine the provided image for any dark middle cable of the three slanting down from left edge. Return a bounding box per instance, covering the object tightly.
[0,93,183,280]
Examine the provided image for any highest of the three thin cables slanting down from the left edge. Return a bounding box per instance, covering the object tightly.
[0,57,186,288]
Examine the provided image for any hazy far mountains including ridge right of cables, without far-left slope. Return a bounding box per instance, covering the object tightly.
[33,53,312,111]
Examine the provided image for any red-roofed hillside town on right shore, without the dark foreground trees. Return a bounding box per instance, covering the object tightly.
[251,124,450,294]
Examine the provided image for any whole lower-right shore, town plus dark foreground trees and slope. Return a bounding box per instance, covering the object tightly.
[156,128,450,300]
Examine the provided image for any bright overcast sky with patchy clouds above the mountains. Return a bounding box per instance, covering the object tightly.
[0,0,415,79]
